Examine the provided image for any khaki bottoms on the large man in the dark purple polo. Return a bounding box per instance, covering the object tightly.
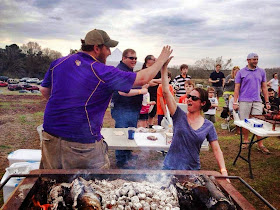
[40,131,110,169]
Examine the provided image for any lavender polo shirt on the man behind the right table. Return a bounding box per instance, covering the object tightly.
[235,66,266,102]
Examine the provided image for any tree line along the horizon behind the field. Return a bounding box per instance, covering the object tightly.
[0,42,280,80]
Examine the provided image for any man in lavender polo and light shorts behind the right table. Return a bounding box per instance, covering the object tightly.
[233,53,270,154]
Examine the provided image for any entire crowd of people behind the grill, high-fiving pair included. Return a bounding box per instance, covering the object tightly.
[40,29,279,175]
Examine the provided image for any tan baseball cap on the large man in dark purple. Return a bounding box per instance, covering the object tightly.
[85,29,119,47]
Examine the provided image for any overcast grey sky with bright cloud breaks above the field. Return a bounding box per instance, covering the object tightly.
[0,0,280,67]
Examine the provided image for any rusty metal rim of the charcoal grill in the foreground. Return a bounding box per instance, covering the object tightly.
[2,169,272,210]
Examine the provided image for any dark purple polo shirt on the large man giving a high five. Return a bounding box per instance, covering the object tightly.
[41,52,136,143]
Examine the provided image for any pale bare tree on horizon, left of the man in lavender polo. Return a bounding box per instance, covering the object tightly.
[195,56,232,70]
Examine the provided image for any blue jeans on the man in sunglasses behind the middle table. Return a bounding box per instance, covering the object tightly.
[111,107,140,167]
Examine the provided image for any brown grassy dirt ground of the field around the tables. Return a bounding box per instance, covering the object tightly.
[0,94,280,209]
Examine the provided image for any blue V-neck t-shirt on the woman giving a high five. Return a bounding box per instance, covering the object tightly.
[164,107,218,170]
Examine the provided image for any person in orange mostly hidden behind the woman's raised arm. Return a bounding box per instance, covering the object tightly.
[157,71,174,125]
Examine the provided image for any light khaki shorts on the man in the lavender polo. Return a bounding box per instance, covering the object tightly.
[239,101,263,120]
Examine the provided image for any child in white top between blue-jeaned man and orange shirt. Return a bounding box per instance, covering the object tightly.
[138,84,156,128]
